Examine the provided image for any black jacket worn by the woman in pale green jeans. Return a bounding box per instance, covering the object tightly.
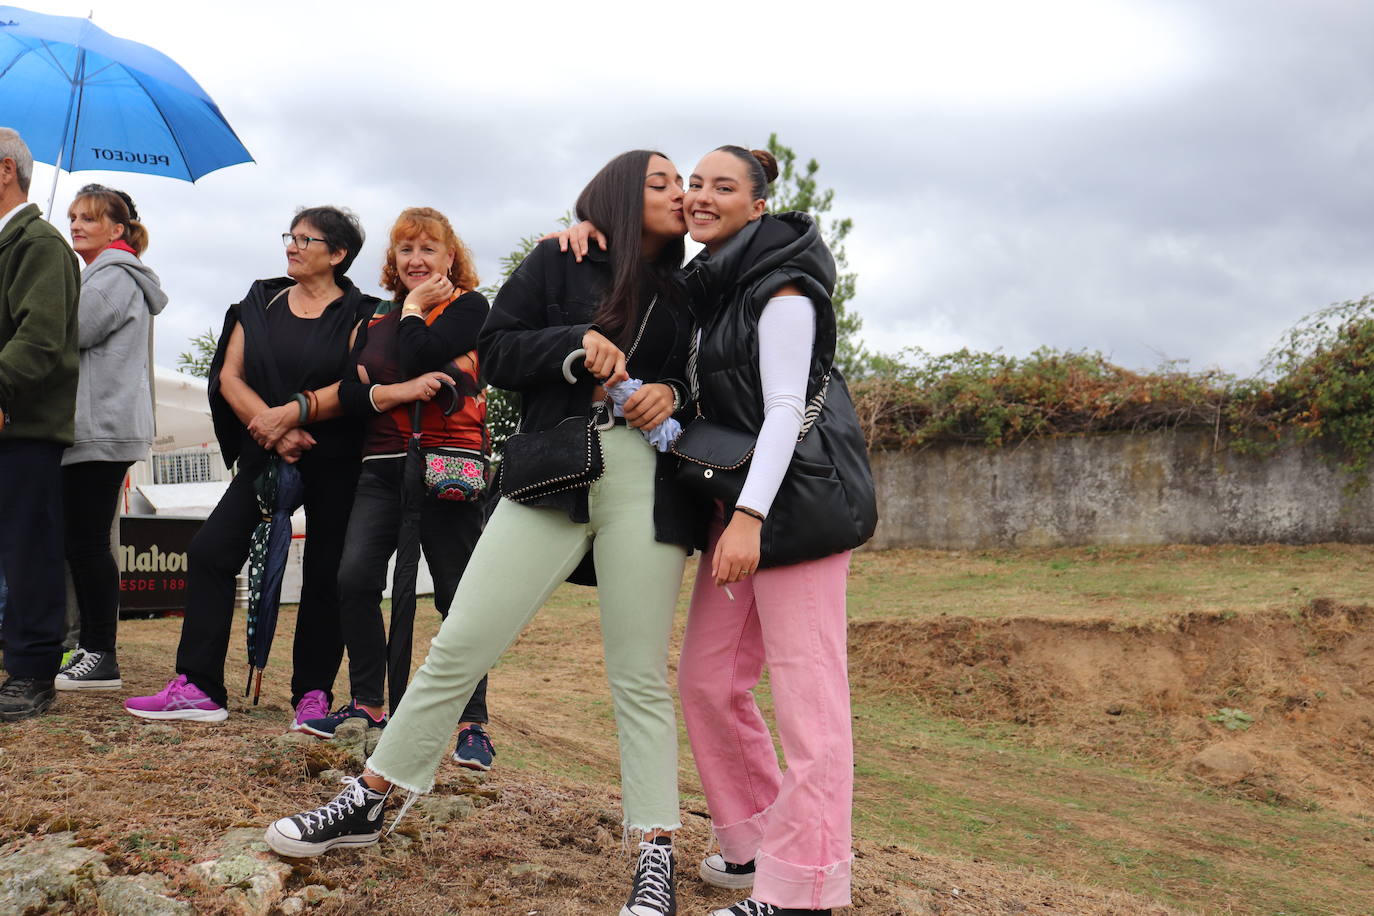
[477,239,706,560]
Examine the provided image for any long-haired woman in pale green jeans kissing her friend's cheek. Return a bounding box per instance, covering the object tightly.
[267,150,706,916]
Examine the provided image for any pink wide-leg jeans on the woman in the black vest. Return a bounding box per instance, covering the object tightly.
[677,519,853,909]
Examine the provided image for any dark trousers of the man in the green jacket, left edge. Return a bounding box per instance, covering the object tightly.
[0,439,67,680]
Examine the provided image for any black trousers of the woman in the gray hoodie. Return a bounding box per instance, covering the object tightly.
[62,461,132,652]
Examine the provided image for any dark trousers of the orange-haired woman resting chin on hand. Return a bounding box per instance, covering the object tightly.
[339,457,488,722]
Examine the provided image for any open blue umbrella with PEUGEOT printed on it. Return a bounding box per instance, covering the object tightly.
[0,7,253,213]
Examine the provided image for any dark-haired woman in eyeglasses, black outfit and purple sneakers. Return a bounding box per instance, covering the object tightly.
[124,206,378,728]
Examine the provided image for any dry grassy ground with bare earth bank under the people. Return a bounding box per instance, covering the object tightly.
[0,547,1374,916]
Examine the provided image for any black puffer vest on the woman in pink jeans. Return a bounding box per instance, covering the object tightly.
[683,213,878,567]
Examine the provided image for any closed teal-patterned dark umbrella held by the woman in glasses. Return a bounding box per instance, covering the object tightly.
[243,455,305,706]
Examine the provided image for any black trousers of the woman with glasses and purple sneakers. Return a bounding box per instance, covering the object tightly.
[176,455,359,706]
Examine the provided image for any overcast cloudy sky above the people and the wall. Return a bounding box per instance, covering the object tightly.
[10,0,1374,374]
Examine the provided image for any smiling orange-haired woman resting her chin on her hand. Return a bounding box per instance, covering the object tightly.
[292,207,495,769]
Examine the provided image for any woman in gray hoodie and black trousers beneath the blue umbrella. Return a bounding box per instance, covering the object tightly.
[56,184,168,691]
